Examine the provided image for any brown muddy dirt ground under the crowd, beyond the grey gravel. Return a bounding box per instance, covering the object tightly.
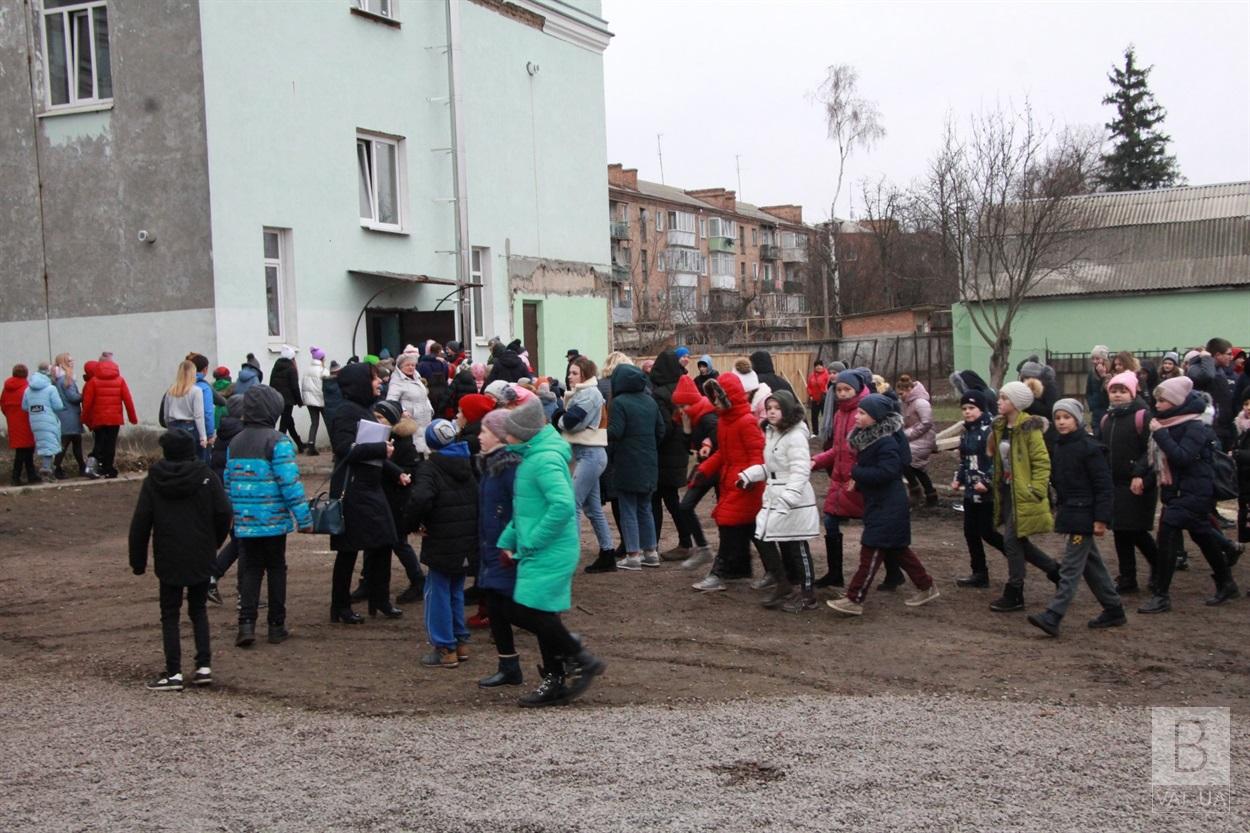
[0,447,1250,715]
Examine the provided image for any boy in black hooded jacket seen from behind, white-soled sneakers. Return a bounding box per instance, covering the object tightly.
[130,429,233,692]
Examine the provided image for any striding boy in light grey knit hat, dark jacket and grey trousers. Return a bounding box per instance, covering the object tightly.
[1029,399,1128,637]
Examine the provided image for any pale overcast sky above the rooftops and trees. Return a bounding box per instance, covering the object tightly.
[604,0,1250,221]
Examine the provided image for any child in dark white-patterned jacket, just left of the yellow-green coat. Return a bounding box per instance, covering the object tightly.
[951,389,1004,588]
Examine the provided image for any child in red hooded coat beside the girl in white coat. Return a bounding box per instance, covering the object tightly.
[691,373,764,593]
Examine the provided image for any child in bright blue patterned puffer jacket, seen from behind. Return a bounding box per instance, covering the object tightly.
[225,384,313,648]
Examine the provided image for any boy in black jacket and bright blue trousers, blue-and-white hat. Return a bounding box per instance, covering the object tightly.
[405,419,478,668]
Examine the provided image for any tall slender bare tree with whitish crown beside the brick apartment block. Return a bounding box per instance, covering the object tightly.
[814,64,885,334]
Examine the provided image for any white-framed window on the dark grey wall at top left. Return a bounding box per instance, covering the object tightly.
[43,0,113,108]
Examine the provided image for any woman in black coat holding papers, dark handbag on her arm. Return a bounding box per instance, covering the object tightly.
[330,361,403,624]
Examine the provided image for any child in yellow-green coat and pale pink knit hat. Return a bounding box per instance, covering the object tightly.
[985,379,1059,613]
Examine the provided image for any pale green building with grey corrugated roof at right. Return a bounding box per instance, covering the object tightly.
[951,183,1250,375]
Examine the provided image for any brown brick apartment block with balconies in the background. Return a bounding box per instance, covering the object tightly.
[608,164,815,344]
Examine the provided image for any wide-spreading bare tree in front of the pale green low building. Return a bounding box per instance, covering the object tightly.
[916,104,1093,386]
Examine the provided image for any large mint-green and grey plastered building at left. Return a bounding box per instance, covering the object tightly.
[0,0,611,420]
